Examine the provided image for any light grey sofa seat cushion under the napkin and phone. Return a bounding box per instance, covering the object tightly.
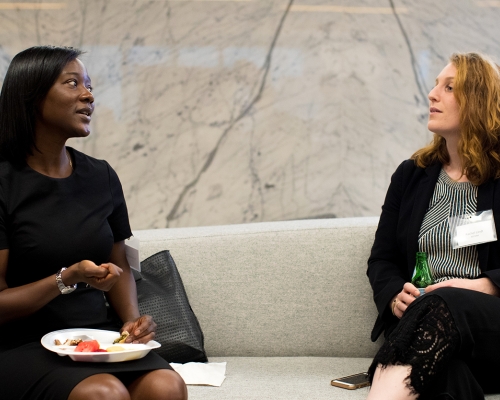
[188,357,500,400]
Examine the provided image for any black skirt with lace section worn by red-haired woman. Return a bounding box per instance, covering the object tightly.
[369,288,500,400]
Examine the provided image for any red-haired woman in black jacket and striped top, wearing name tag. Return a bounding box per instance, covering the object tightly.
[368,53,500,400]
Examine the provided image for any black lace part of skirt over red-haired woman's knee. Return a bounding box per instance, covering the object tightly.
[368,294,460,394]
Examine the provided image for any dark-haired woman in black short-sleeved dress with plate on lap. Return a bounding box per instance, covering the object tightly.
[0,46,187,400]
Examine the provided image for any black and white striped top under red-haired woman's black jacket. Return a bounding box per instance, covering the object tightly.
[418,169,481,282]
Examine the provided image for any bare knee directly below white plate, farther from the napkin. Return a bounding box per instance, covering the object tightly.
[68,374,130,400]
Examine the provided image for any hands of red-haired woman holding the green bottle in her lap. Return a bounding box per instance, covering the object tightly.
[391,277,500,318]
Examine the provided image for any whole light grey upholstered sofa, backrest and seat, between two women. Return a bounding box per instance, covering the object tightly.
[134,217,500,400]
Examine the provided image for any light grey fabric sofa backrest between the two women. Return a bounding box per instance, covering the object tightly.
[134,218,377,357]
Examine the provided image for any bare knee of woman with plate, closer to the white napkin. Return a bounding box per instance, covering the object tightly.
[128,369,188,400]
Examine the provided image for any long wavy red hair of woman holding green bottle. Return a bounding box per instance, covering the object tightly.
[411,53,500,185]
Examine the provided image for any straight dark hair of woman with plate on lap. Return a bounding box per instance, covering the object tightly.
[0,46,82,163]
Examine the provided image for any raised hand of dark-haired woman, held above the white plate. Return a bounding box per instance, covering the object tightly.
[66,260,123,292]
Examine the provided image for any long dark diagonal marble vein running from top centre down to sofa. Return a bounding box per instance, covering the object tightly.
[166,0,294,228]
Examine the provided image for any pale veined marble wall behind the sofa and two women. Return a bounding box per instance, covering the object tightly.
[0,0,500,229]
